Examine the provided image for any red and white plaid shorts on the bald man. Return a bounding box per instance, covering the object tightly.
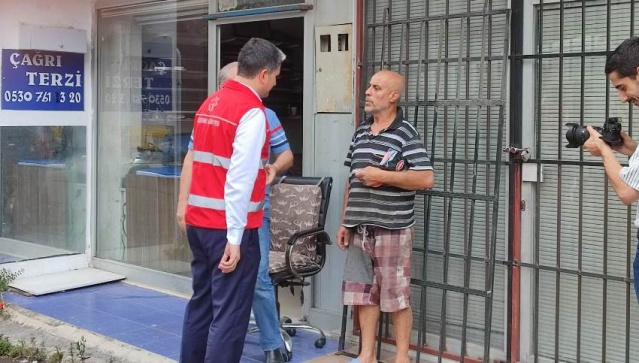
[342,226,413,312]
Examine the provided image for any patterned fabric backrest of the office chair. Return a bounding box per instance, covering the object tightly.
[271,177,333,260]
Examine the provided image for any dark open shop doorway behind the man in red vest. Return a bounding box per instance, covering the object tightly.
[219,17,304,176]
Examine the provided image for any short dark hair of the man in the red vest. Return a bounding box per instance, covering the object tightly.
[237,38,286,78]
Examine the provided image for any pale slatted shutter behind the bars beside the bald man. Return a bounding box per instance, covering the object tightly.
[361,0,508,356]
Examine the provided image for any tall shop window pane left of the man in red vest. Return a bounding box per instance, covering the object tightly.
[97,6,208,274]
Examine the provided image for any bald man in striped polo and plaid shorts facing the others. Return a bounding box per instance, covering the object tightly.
[337,70,435,363]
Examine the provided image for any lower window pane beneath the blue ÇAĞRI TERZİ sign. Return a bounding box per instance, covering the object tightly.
[0,126,86,263]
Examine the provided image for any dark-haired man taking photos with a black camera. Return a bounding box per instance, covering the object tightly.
[583,37,639,306]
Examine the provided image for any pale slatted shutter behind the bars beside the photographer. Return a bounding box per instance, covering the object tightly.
[533,1,639,362]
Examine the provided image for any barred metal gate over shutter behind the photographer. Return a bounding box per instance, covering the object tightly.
[518,0,639,362]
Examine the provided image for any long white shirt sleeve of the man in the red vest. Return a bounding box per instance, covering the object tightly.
[224,108,266,245]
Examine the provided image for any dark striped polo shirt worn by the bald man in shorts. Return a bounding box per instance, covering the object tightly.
[343,107,433,229]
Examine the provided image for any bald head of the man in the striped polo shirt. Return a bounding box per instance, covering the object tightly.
[364,70,404,114]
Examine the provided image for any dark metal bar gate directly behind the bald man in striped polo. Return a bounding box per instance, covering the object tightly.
[345,0,510,362]
